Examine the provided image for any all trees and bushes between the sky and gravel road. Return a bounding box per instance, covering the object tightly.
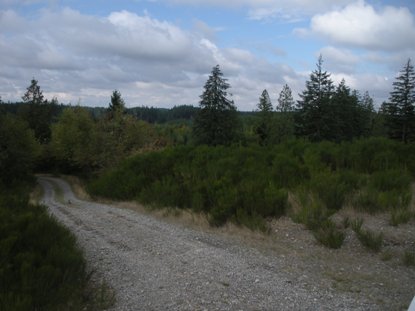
[0,57,415,310]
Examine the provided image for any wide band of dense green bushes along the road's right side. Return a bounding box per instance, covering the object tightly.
[89,138,413,235]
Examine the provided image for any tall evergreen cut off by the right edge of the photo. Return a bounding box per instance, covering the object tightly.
[385,59,415,143]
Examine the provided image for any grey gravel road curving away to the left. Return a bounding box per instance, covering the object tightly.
[39,177,415,310]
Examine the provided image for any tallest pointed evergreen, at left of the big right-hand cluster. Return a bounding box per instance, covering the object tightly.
[296,56,333,141]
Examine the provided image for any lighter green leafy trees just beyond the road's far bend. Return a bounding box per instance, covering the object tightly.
[50,107,153,173]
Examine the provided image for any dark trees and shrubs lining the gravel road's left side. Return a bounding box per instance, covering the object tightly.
[0,115,113,310]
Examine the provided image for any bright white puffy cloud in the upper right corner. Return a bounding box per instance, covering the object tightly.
[311,0,415,51]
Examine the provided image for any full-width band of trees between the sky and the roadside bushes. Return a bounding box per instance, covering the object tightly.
[0,56,415,177]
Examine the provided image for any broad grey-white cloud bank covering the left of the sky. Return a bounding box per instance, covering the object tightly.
[0,8,306,110]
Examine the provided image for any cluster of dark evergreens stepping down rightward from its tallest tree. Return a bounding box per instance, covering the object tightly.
[295,56,373,142]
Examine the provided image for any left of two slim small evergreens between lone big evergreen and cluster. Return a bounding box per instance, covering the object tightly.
[256,90,272,145]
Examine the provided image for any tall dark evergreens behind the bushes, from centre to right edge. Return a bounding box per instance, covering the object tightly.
[193,56,415,145]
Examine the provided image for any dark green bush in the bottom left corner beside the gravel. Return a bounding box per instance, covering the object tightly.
[0,188,88,310]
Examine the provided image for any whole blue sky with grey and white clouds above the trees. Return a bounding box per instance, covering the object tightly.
[0,0,415,111]
